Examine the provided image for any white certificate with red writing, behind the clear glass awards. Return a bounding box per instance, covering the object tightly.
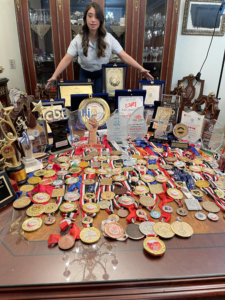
[118,96,144,118]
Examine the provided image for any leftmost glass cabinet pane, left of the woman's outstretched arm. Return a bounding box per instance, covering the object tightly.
[28,0,55,87]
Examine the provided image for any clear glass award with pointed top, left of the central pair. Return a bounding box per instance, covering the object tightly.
[106,110,128,142]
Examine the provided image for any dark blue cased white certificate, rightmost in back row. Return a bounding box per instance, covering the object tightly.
[138,80,166,107]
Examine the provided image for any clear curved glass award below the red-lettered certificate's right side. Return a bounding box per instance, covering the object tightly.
[127,106,148,140]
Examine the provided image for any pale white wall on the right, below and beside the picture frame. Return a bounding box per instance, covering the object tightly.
[172,0,225,124]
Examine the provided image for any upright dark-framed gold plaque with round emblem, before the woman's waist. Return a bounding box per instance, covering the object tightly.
[102,64,127,98]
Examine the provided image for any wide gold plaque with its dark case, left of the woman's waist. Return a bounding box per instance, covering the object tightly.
[57,80,94,107]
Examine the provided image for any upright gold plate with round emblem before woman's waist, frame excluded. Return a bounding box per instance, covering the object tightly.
[106,68,124,97]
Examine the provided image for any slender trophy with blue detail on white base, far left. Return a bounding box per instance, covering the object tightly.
[16,118,43,173]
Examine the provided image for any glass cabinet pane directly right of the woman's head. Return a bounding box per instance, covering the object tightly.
[105,0,126,62]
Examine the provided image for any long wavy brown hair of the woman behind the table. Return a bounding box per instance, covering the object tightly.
[81,2,107,58]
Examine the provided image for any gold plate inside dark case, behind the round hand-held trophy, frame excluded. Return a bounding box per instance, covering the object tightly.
[59,84,93,106]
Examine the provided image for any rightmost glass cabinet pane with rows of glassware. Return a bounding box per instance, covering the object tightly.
[143,0,167,80]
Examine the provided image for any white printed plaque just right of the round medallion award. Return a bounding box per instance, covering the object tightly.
[181,111,205,143]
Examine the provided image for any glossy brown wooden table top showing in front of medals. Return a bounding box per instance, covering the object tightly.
[0,183,225,299]
